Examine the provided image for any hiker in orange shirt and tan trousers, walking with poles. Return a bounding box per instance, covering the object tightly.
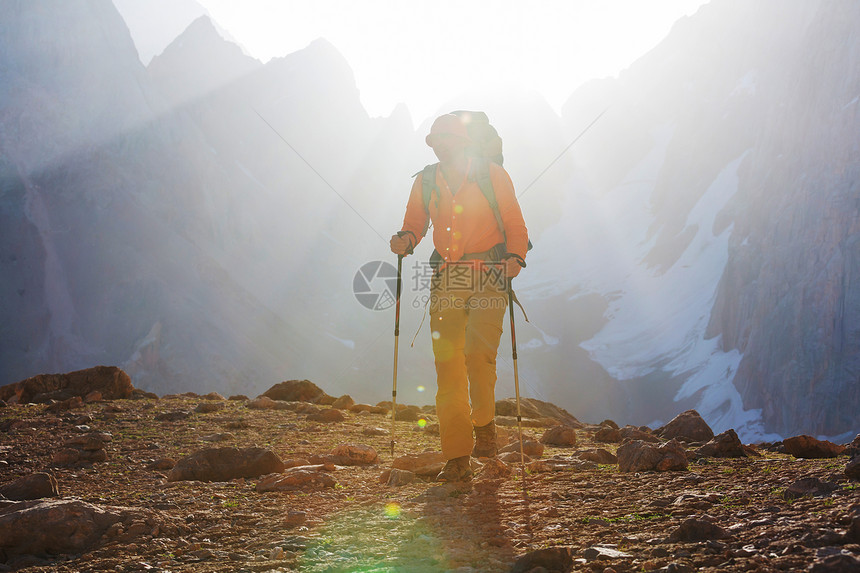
[391,114,529,482]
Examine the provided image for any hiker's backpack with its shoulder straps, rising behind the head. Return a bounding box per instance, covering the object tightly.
[415,110,532,254]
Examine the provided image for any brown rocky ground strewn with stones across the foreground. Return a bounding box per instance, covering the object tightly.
[0,378,860,572]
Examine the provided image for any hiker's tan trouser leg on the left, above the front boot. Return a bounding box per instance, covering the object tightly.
[430,280,473,460]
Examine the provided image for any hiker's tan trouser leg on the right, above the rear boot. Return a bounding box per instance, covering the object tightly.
[464,291,507,426]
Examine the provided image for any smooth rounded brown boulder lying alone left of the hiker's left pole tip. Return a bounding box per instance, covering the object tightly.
[167,448,284,481]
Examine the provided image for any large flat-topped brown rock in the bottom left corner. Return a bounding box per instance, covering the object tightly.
[0,500,147,558]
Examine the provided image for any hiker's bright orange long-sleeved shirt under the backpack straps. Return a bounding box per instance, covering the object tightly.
[401,159,529,262]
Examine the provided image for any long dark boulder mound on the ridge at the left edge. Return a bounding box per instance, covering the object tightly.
[0,366,134,404]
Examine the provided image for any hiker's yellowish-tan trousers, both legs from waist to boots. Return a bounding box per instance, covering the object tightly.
[430,264,507,460]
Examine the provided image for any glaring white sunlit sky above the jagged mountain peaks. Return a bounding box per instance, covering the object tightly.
[193,0,706,122]
